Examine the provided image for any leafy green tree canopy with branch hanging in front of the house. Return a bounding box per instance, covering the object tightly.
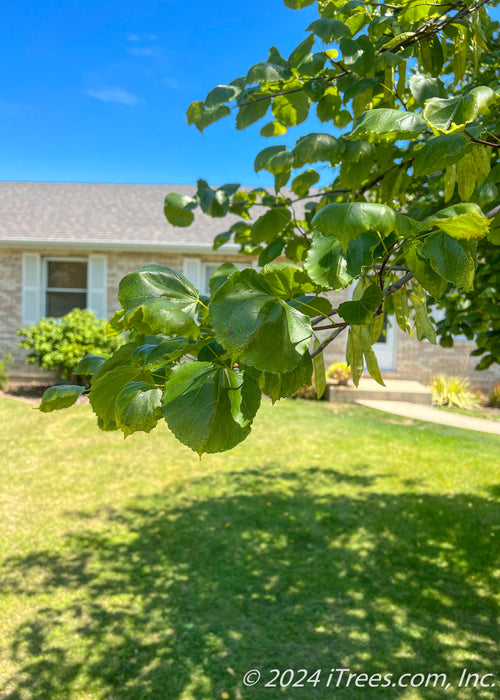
[42,0,500,455]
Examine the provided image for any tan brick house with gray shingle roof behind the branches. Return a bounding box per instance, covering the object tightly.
[0,182,500,387]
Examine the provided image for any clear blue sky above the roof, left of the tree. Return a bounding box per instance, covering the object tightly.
[0,0,499,186]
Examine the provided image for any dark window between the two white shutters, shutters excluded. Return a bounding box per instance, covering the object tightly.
[42,258,87,318]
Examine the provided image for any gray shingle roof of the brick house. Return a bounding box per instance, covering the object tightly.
[0,182,244,251]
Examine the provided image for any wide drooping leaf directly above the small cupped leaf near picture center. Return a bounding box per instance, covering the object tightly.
[312,202,398,251]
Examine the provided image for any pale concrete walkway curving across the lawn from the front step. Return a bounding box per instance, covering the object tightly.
[356,399,500,435]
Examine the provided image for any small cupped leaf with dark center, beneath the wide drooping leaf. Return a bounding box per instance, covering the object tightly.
[305,232,352,289]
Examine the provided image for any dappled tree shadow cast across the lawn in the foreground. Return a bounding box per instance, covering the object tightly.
[0,471,500,700]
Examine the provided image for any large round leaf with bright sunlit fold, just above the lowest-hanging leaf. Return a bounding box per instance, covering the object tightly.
[210,265,313,372]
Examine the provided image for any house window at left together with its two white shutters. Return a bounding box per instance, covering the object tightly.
[22,253,107,325]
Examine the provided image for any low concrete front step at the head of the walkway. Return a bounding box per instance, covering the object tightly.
[328,377,432,406]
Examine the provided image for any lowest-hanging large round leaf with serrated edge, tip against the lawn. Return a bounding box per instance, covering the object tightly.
[162,362,260,456]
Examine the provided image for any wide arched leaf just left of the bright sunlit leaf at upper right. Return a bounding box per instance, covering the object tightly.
[347,109,427,142]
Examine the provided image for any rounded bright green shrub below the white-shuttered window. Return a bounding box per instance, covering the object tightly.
[17,309,124,379]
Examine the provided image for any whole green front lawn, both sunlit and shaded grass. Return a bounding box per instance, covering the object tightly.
[0,399,500,700]
